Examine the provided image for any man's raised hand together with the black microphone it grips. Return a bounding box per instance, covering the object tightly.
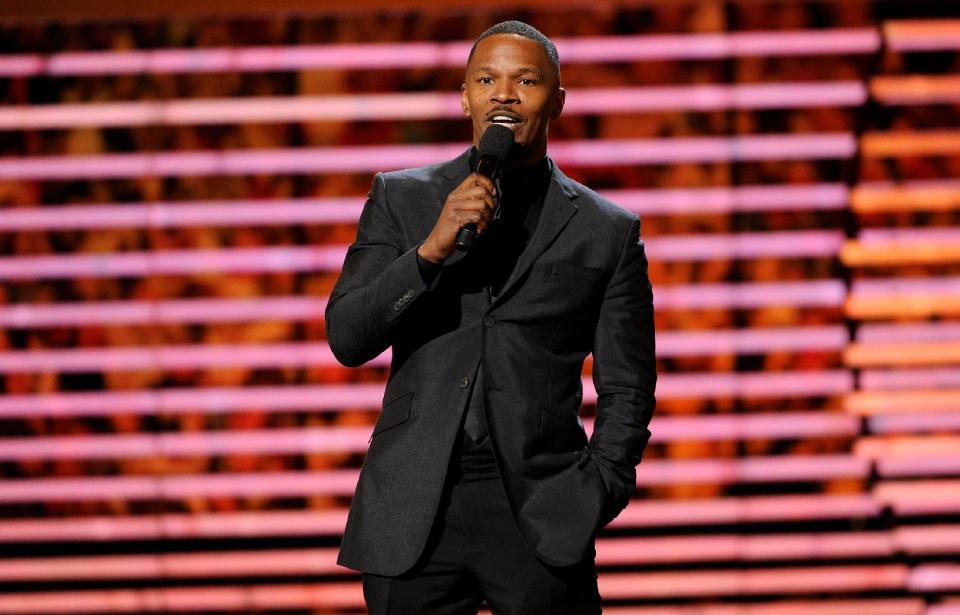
[418,124,513,263]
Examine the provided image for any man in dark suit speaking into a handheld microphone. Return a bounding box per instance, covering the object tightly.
[326,22,656,615]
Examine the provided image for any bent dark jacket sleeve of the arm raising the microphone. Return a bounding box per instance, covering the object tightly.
[325,173,437,367]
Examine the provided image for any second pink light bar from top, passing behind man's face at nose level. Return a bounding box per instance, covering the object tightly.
[0,81,866,130]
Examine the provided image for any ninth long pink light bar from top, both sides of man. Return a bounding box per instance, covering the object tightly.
[0,414,859,461]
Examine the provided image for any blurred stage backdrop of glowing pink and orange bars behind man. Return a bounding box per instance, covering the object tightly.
[0,0,960,615]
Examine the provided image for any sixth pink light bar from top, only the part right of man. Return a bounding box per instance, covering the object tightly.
[653,280,847,309]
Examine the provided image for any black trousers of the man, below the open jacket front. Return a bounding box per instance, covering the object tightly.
[363,478,600,615]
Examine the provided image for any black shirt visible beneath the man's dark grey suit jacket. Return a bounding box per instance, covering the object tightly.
[417,147,552,480]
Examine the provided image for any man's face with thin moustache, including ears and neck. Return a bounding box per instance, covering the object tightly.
[461,34,565,165]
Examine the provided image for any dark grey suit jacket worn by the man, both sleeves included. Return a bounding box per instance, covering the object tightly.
[326,152,656,576]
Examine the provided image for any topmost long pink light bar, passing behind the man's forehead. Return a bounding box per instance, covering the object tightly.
[0,28,879,76]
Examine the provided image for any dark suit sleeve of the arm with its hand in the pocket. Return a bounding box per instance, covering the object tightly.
[589,218,657,525]
